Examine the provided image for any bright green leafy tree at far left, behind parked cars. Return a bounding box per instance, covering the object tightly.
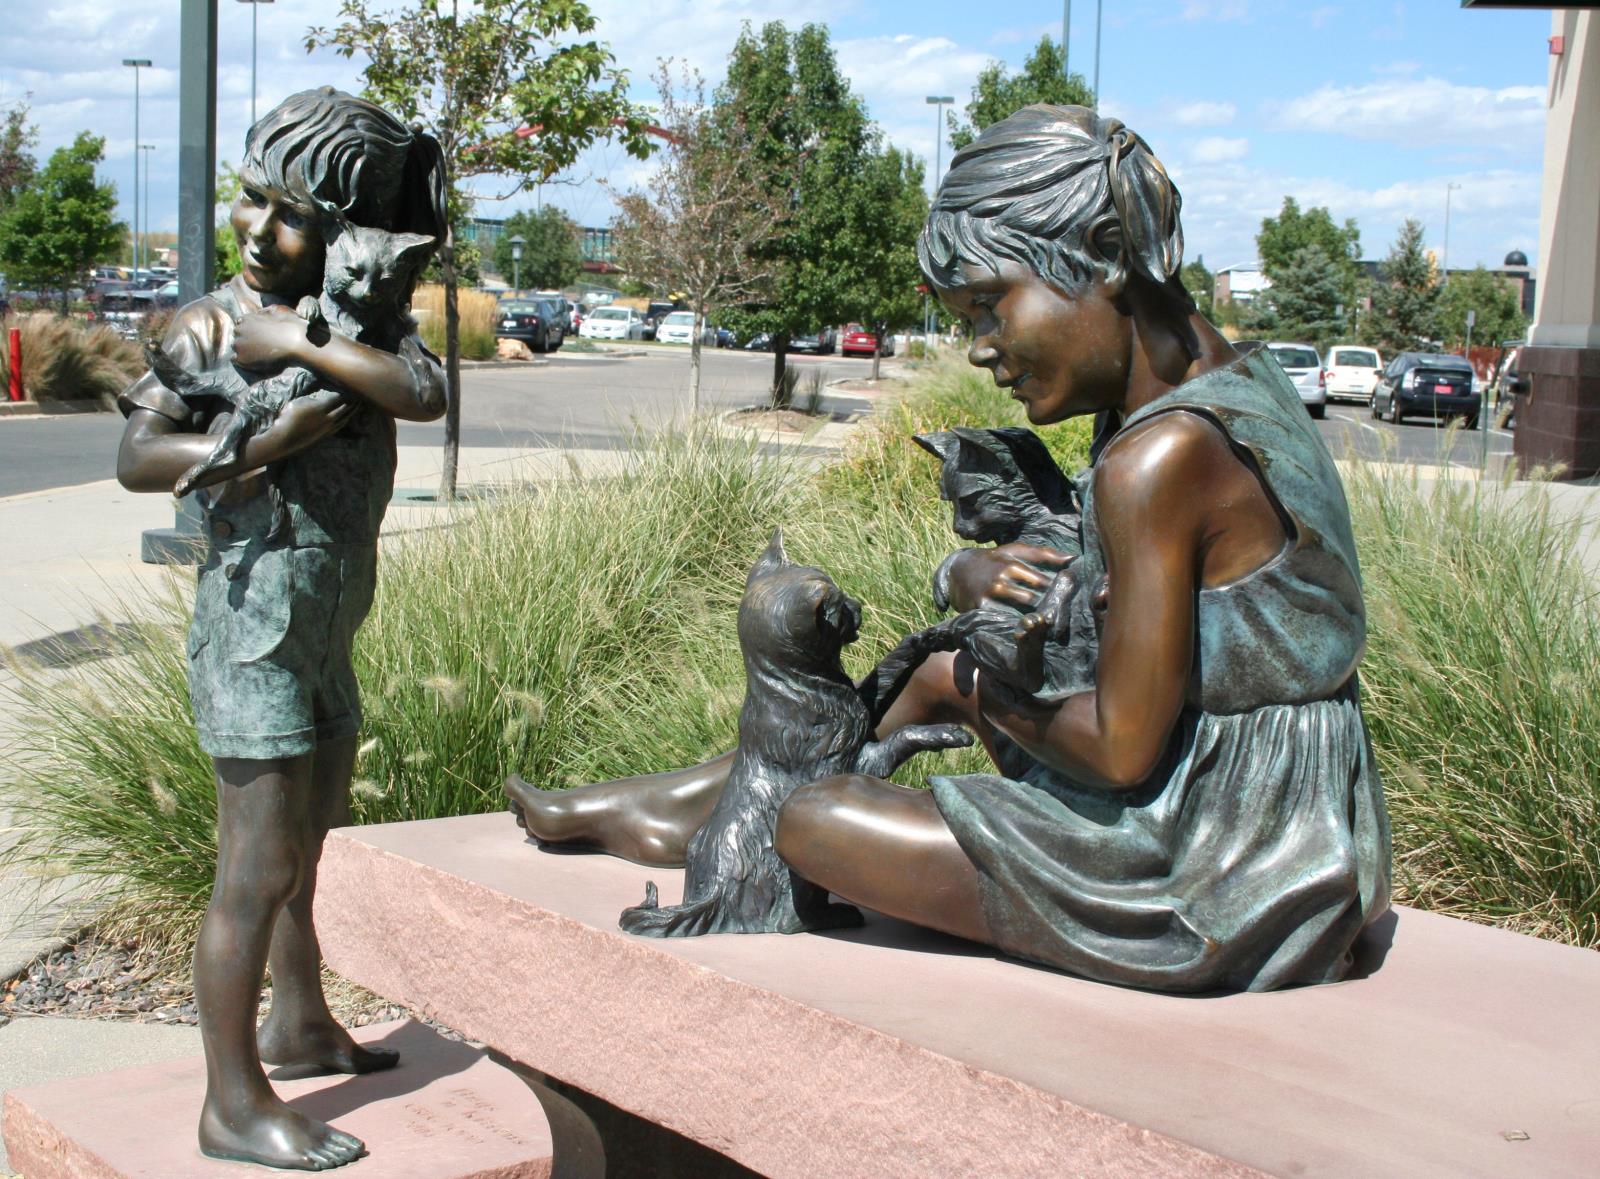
[0,131,126,312]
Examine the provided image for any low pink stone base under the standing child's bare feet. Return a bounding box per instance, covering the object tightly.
[5,1022,554,1179]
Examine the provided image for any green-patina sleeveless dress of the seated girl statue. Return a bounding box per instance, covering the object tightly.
[931,352,1390,992]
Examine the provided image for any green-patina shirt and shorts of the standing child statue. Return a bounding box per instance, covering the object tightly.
[118,278,434,760]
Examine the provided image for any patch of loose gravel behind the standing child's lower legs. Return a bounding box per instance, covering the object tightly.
[0,933,441,1040]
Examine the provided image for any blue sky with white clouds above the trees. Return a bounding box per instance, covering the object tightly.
[0,0,1550,270]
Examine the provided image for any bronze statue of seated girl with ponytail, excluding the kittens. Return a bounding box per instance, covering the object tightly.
[509,106,1390,993]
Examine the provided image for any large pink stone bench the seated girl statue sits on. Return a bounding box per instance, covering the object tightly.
[317,814,1600,1179]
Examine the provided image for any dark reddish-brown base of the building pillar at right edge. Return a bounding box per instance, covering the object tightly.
[1512,346,1600,478]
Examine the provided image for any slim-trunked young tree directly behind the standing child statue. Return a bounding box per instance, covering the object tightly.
[306,0,650,499]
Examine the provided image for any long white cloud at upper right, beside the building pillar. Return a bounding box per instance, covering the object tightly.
[1269,77,1544,149]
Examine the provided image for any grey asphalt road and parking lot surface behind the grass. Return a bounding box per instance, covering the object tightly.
[0,349,1510,498]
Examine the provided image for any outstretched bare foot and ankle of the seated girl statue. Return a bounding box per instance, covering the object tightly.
[506,753,733,867]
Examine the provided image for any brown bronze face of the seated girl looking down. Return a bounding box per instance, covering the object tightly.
[936,261,1133,426]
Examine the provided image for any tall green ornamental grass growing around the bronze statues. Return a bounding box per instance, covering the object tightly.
[0,351,1600,947]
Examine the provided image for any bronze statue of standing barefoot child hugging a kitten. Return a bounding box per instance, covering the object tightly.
[117,88,445,1169]
